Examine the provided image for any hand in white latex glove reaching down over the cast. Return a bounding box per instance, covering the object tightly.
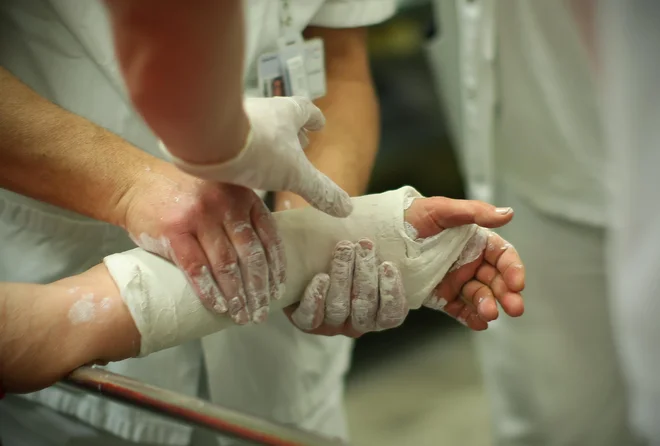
[161,97,353,217]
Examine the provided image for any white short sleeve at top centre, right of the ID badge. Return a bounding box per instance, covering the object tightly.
[309,0,397,28]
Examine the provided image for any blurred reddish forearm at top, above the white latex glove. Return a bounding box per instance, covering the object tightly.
[105,0,249,164]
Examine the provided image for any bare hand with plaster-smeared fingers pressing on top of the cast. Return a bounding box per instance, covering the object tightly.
[122,162,286,324]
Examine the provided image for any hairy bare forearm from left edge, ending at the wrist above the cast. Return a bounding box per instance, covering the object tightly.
[0,68,158,225]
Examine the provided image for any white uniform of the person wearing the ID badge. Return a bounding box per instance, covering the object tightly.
[0,0,395,446]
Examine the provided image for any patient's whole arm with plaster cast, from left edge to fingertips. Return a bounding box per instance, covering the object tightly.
[0,191,524,392]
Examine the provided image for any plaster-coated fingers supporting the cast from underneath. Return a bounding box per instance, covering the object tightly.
[285,239,408,337]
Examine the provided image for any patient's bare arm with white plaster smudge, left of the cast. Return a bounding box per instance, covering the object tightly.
[0,265,140,393]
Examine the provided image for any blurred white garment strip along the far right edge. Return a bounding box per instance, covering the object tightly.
[600,0,660,446]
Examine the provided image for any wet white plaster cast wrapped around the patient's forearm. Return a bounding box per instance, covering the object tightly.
[104,187,478,356]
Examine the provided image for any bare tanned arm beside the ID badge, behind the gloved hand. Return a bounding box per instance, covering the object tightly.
[276,27,380,210]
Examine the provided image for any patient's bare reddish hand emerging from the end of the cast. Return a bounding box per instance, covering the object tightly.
[405,197,525,331]
